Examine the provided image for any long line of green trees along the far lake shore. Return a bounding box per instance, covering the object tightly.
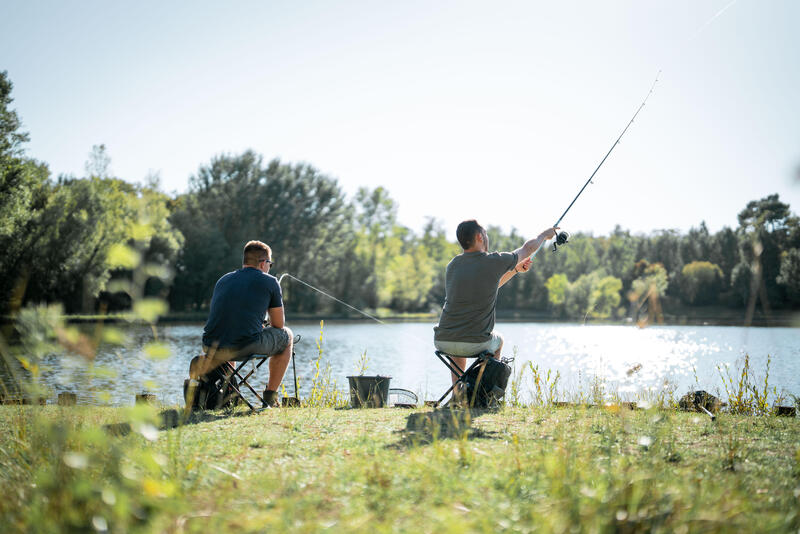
[0,72,800,318]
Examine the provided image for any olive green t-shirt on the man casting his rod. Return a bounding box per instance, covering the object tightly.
[433,252,518,343]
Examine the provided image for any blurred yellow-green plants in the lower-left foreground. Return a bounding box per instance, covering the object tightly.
[0,232,183,532]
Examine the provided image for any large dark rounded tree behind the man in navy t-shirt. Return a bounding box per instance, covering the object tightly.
[170,151,352,311]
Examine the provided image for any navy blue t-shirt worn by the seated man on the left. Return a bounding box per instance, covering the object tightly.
[203,267,283,348]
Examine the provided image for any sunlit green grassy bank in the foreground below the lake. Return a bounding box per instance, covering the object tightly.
[0,406,800,532]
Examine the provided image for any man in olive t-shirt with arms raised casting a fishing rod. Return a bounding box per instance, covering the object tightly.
[433,219,557,380]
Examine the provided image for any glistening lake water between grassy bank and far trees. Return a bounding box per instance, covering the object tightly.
[34,322,800,405]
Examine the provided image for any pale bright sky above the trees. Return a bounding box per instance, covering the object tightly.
[0,0,800,237]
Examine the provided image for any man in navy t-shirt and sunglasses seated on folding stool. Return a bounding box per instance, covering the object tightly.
[189,241,292,406]
